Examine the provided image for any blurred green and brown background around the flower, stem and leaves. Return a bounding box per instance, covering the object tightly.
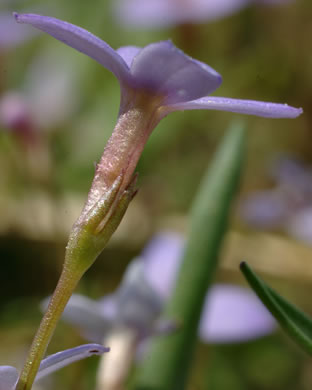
[0,0,312,390]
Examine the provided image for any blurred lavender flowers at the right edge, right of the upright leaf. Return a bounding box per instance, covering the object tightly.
[240,157,312,244]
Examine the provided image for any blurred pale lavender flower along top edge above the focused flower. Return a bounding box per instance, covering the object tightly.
[113,0,289,29]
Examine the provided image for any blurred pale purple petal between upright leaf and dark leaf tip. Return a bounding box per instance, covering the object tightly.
[199,284,276,343]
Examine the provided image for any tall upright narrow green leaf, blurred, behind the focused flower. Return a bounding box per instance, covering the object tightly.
[135,125,245,390]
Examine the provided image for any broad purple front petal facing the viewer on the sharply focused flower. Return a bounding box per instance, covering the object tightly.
[130,41,222,104]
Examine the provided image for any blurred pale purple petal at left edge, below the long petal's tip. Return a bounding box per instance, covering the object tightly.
[0,12,36,50]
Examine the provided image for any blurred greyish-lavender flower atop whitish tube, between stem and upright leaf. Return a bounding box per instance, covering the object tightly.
[42,259,168,342]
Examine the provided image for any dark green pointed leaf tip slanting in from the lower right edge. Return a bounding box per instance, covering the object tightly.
[240,262,312,355]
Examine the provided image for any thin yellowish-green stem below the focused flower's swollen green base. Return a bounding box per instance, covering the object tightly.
[16,266,83,390]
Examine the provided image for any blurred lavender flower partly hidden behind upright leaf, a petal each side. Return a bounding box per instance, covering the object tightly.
[142,232,275,343]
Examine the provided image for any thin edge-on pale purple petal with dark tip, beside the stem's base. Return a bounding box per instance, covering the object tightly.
[36,344,109,381]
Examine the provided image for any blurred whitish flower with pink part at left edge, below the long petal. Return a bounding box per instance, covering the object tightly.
[0,46,79,133]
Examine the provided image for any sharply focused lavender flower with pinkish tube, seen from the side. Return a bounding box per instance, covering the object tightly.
[14,13,302,224]
